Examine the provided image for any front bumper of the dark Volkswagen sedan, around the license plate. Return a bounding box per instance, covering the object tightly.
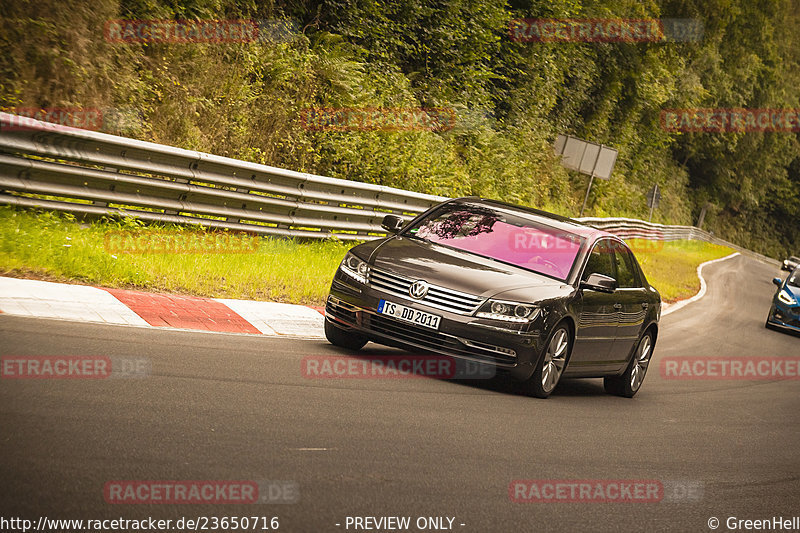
[325,273,544,379]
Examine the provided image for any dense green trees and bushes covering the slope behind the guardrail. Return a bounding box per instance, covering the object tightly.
[0,0,800,256]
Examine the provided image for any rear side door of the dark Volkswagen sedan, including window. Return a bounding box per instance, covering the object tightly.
[611,242,649,365]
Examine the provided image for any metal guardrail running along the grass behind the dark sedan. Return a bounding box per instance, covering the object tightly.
[0,113,777,263]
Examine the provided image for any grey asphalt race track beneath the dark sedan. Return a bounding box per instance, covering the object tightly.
[0,252,800,532]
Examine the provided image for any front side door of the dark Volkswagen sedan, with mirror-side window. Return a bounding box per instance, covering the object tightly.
[569,239,621,373]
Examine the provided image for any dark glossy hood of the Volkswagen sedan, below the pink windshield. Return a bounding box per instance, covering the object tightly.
[364,237,572,300]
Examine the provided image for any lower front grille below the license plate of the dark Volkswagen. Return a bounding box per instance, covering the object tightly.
[362,313,517,365]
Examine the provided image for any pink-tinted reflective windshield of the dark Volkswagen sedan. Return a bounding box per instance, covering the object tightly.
[405,204,584,281]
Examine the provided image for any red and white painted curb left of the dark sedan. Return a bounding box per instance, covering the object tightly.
[0,277,324,338]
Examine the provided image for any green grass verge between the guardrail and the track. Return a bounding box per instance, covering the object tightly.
[0,208,732,305]
